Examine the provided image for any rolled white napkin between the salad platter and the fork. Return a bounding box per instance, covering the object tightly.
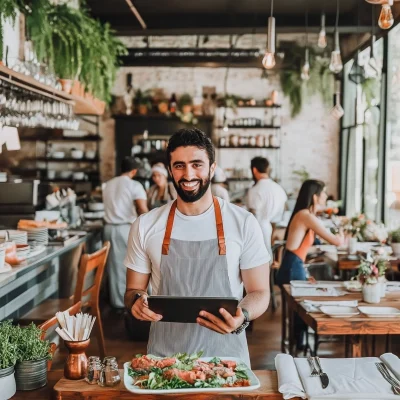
[275,354,306,399]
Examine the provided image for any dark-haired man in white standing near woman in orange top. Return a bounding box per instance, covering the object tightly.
[247,157,287,253]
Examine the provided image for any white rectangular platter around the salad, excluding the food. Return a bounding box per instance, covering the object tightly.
[124,357,260,394]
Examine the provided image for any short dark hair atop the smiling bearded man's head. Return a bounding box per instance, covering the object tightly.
[167,128,215,166]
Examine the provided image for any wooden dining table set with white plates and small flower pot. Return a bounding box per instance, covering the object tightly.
[281,285,400,357]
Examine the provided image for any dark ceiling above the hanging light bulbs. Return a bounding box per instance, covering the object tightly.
[87,0,379,36]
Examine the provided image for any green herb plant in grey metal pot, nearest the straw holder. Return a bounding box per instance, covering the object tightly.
[14,323,51,390]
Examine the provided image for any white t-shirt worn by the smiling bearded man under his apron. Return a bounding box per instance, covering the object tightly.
[124,199,271,299]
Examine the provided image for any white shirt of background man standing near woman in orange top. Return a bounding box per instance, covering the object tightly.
[247,179,287,223]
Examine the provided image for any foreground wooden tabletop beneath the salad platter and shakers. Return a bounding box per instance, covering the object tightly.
[12,370,297,400]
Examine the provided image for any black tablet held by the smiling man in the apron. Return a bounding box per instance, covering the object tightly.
[147,296,239,323]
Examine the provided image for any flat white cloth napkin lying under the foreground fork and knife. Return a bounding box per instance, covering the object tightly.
[294,357,399,400]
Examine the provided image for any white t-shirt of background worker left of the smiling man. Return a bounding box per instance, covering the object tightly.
[103,175,147,224]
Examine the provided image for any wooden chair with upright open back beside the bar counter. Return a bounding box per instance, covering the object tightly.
[19,242,110,358]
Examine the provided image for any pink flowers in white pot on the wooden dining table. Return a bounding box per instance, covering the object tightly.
[357,258,381,303]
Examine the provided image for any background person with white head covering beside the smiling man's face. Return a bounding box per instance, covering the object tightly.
[147,163,176,210]
